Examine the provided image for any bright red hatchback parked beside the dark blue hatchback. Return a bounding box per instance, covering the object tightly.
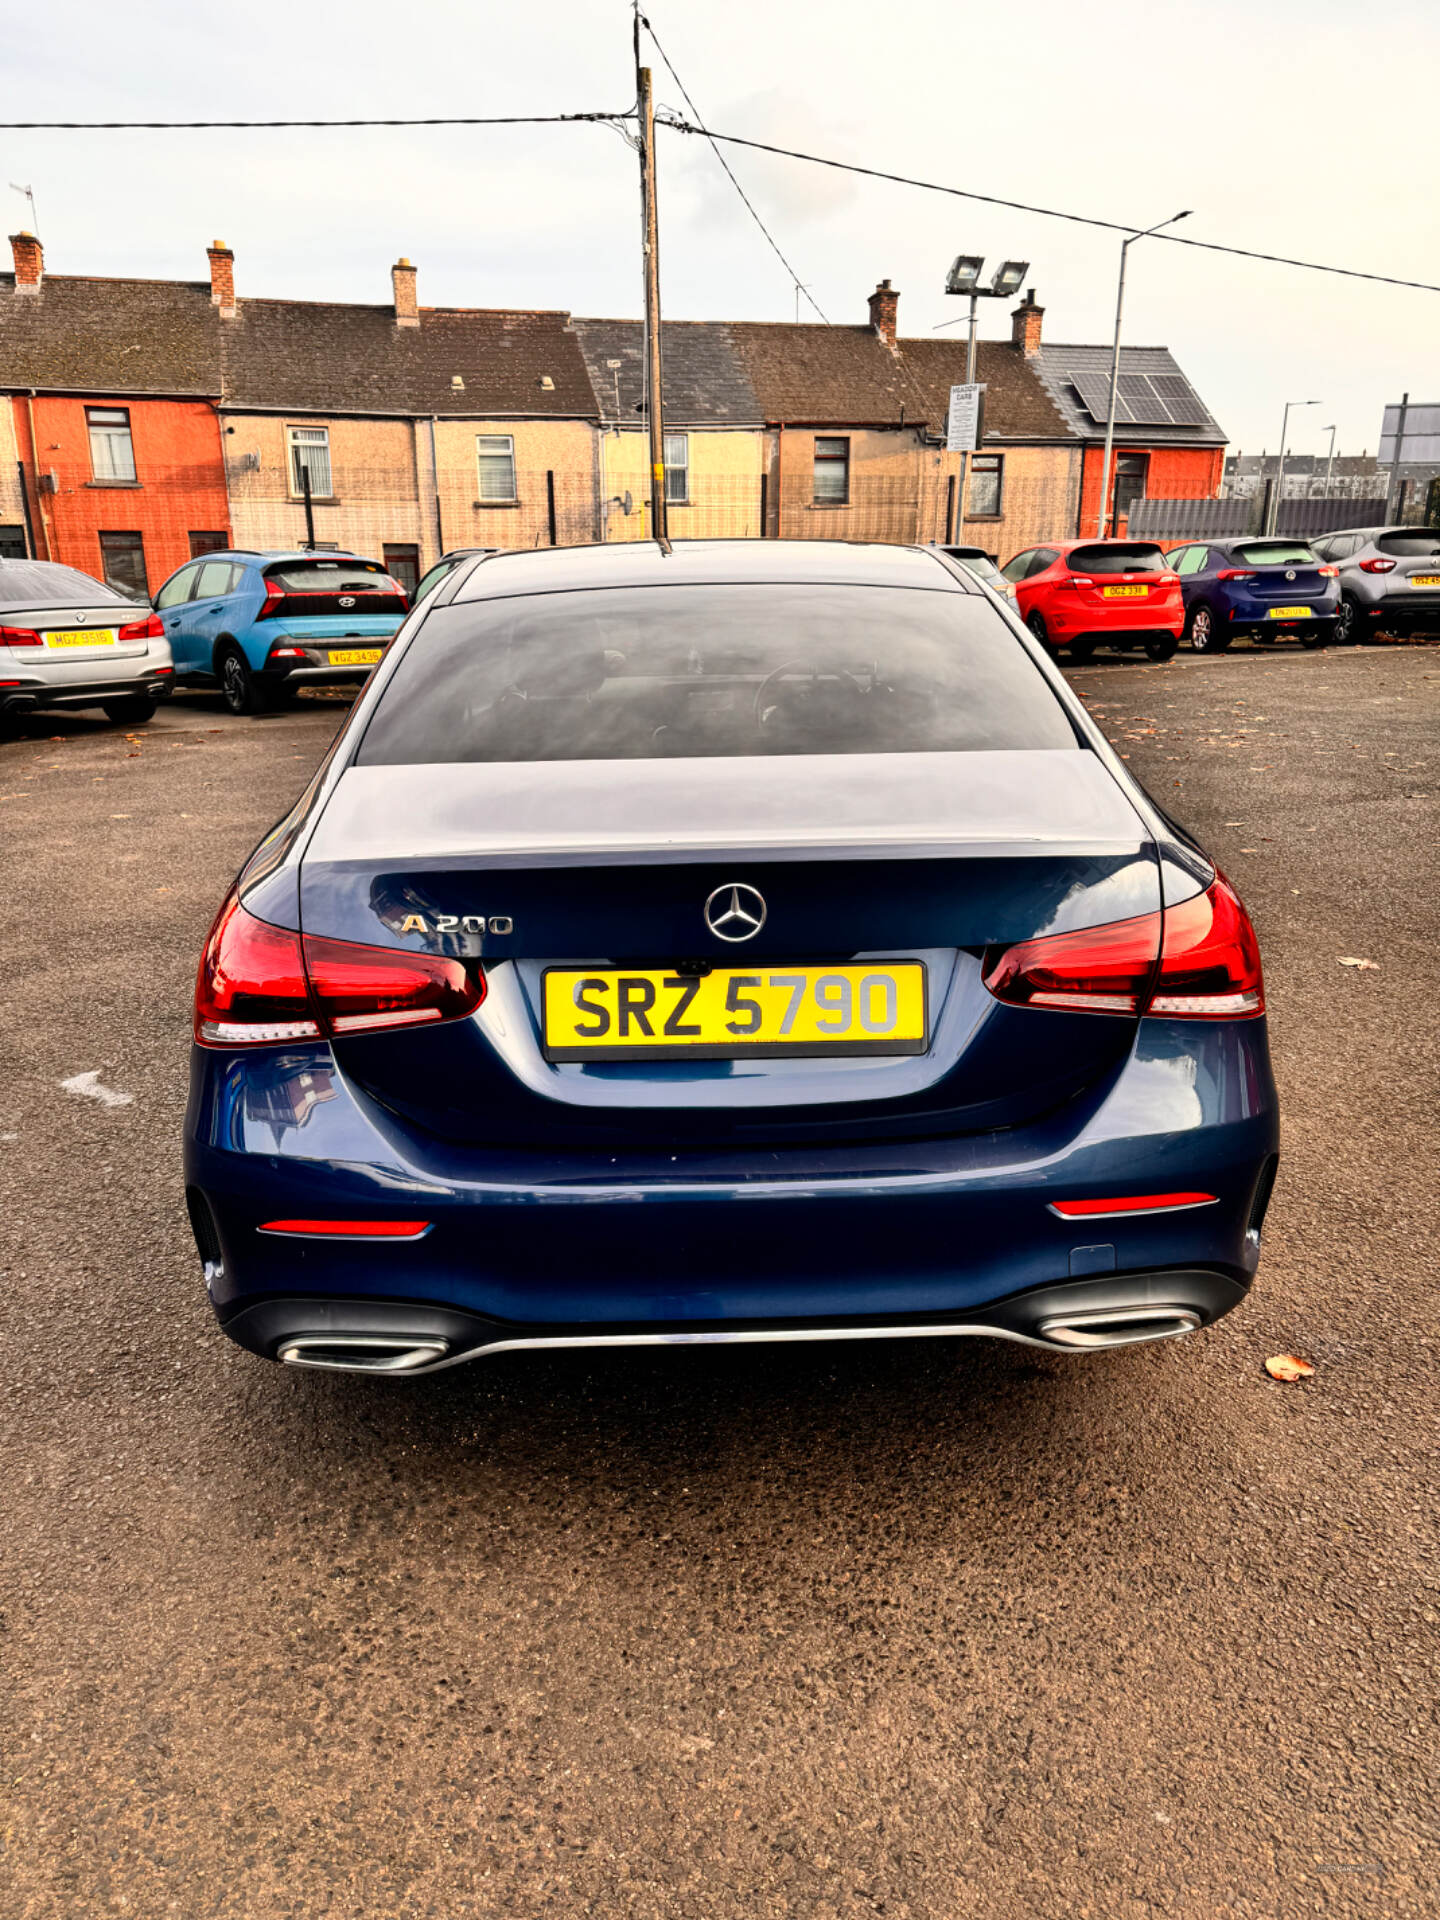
[1000,540,1185,660]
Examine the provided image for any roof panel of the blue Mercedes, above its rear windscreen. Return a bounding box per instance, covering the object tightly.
[449,540,975,601]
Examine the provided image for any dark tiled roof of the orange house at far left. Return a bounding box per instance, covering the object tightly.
[0,273,221,397]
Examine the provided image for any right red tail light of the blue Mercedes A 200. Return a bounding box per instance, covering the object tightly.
[983,874,1265,1020]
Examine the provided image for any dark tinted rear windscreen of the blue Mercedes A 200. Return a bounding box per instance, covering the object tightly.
[355,586,1077,768]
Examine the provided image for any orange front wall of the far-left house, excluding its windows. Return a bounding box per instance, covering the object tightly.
[10,394,230,593]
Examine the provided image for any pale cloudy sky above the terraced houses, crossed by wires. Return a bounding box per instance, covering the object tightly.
[0,0,1440,451]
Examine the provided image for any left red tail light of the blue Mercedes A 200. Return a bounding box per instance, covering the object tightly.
[196,893,486,1046]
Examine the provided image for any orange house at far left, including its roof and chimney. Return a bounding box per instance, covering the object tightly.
[0,234,230,595]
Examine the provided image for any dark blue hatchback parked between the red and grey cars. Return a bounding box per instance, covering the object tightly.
[1165,538,1340,653]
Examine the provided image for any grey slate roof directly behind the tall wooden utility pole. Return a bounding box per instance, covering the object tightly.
[572,321,764,426]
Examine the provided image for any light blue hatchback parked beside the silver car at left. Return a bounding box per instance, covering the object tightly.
[156,551,409,714]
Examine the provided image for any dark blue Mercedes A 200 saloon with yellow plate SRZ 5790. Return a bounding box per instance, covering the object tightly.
[186,540,1277,1375]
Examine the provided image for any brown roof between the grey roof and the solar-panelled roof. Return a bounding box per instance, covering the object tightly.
[732,321,1071,442]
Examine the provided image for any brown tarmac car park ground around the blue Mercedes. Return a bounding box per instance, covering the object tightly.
[0,649,1440,1920]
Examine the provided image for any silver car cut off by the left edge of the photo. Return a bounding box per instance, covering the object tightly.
[0,561,175,726]
